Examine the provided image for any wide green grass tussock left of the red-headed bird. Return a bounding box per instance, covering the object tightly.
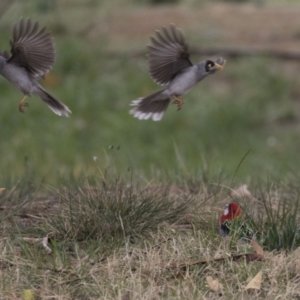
[48,180,191,241]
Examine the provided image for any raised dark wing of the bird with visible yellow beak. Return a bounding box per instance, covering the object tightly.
[148,24,192,85]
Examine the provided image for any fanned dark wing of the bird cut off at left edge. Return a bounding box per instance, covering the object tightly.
[8,19,55,77]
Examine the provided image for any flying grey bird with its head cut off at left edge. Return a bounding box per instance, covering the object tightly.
[0,19,71,117]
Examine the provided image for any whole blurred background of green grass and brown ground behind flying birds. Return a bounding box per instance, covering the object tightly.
[0,0,300,183]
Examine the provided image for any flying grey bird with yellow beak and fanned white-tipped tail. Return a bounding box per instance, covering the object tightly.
[130,24,226,121]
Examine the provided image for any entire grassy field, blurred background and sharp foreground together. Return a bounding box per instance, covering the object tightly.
[0,0,300,300]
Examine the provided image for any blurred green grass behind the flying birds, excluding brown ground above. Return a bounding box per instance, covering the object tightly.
[0,4,299,182]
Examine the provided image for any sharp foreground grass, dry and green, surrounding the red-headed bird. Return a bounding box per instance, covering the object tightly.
[0,173,300,300]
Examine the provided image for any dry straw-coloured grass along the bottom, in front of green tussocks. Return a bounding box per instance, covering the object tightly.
[0,224,300,299]
